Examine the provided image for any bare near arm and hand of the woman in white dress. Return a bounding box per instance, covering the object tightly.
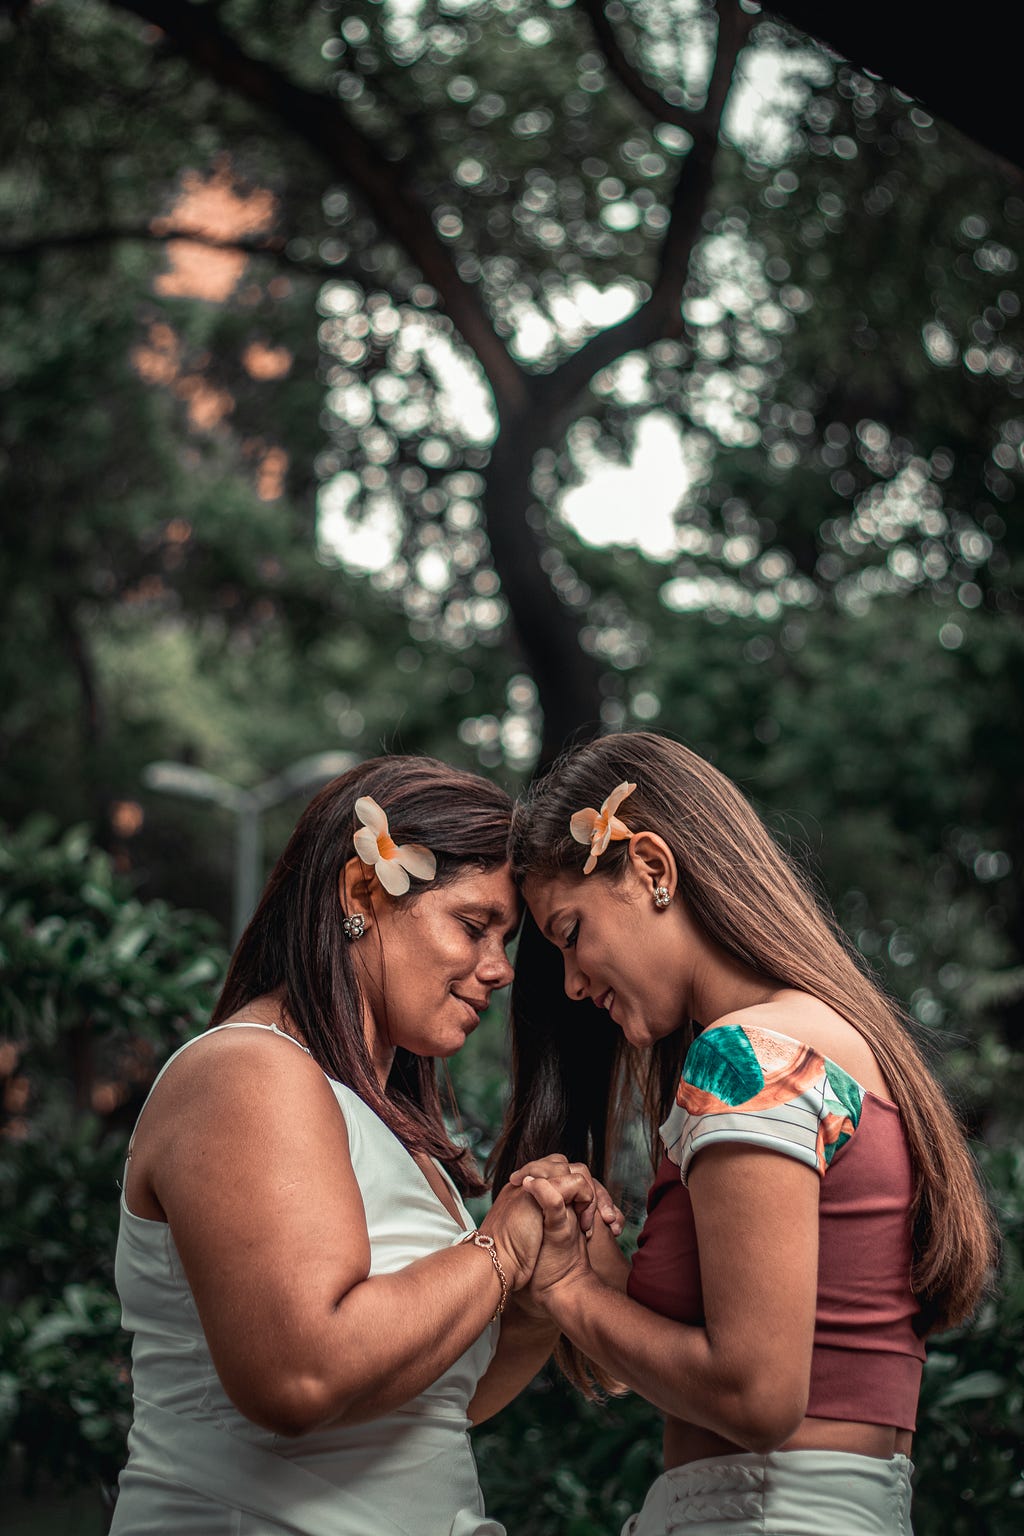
[134,1031,540,1435]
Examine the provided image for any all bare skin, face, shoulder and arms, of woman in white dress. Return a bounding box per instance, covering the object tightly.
[126,860,606,1435]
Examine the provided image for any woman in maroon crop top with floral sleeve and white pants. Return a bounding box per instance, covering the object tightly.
[496,733,995,1536]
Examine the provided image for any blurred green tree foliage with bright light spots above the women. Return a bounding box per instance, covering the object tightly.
[0,0,1024,983]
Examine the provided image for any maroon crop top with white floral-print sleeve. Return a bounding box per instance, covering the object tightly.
[628,1025,924,1430]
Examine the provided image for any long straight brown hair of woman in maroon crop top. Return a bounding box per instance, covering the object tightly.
[493,731,996,1332]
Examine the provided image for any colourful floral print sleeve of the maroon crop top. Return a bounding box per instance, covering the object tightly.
[660,1025,864,1183]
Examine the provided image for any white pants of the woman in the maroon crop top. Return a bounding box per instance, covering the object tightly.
[622,1450,913,1536]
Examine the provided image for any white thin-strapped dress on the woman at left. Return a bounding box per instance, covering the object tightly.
[111,1023,505,1536]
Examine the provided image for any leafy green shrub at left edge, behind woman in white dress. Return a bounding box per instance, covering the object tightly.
[0,819,224,1487]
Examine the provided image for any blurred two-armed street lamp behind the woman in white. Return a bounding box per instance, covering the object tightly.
[143,751,359,945]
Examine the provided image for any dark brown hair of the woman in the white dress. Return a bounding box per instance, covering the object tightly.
[210,756,511,1195]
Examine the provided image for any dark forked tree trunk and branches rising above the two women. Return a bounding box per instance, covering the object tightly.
[92,0,752,757]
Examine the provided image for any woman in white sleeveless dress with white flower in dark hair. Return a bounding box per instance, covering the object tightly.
[112,757,593,1536]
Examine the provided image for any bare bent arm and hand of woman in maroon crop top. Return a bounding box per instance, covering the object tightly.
[525,1144,818,1452]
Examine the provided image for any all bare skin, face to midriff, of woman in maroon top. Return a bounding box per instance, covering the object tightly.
[513,833,909,1467]
